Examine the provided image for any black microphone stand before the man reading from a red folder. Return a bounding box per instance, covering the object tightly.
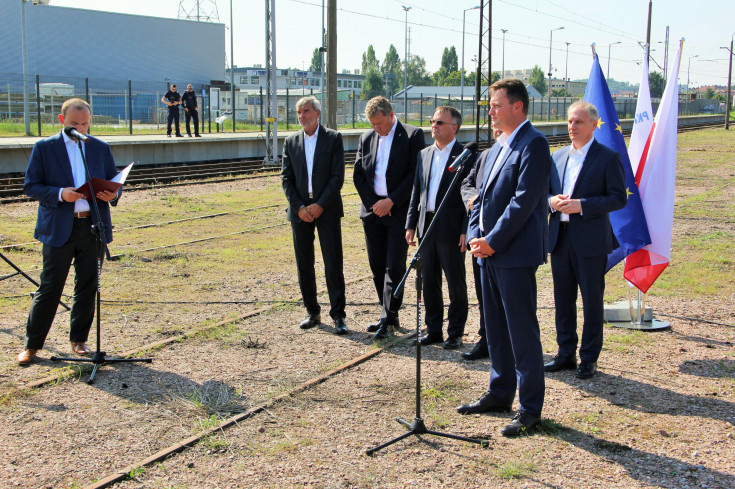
[51,138,153,384]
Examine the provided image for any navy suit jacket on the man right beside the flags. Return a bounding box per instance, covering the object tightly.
[548,141,628,256]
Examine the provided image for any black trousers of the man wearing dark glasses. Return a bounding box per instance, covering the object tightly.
[421,233,468,338]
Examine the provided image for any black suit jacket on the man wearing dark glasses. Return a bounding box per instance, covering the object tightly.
[406,142,472,242]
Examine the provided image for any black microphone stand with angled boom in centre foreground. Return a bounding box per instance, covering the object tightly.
[365,152,489,456]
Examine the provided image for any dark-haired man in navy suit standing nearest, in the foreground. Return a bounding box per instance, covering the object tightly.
[457,79,551,436]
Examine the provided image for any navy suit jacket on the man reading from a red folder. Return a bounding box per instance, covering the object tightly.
[23,132,120,247]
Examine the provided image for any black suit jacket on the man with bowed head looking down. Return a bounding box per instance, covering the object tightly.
[353,121,426,222]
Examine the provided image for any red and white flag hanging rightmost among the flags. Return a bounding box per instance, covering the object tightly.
[623,39,684,293]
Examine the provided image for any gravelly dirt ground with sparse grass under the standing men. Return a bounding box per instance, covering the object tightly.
[0,127,735,489]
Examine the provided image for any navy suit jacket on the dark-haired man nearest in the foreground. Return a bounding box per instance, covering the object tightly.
[467,122,551,268]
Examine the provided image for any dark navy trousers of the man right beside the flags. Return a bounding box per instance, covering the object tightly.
[551,226,607,362]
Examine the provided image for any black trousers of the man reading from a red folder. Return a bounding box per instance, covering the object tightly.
[26,217,97,350]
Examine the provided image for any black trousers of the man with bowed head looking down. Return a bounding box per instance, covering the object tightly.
[362,214,408,323]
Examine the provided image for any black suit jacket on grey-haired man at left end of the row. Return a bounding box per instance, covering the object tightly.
[281,124,345,221]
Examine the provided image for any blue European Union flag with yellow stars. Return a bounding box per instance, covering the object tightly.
[584,54,651,271]
